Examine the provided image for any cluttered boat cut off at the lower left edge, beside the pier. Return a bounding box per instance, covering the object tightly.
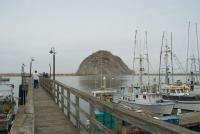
[0,84,16,132]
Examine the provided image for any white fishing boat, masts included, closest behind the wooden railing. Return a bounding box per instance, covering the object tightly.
[120,30,174,114]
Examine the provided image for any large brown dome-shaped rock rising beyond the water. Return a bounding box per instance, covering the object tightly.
[77,50,131,75]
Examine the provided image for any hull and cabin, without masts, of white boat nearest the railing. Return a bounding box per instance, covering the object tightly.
[120,86,174,114]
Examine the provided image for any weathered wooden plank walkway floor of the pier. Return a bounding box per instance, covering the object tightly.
[33,88,78,134]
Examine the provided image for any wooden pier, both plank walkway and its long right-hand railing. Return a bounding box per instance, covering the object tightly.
[13,78,200,134]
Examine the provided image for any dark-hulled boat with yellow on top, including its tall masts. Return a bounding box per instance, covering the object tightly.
[159,25,200,111]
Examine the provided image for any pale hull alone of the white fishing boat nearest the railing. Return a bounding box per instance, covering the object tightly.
[121,100,174,114]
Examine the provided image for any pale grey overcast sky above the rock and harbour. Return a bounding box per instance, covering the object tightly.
[0,0,200,73]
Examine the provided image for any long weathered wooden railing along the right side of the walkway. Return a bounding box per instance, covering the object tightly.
[40,77,196,134]
